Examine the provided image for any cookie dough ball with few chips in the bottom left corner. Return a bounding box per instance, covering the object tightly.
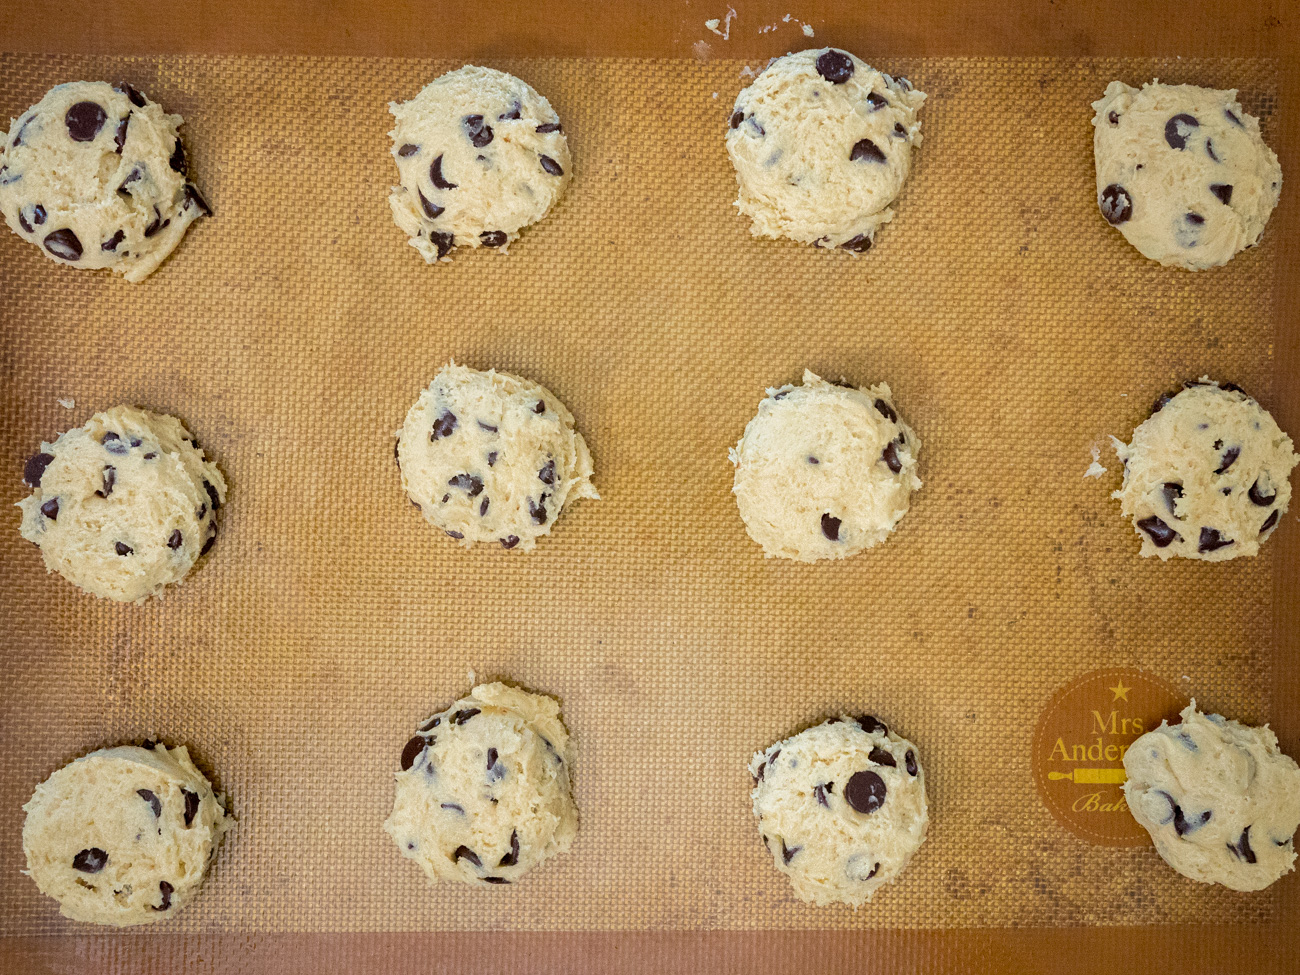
[22,742,233,927]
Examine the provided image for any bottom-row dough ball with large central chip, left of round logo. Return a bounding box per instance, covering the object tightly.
[749,715,930,909]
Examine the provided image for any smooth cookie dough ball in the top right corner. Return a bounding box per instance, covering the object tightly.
[1092,82,1282,270]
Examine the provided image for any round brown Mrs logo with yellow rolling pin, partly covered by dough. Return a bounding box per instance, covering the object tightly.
[1034,667,1187,846]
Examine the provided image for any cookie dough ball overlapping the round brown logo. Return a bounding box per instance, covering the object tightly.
[1125,701,1300,891]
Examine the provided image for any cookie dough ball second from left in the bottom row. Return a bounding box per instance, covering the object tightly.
[384,684,577,884]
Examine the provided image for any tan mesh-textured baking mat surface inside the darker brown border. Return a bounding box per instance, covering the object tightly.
[0,55,1279,935]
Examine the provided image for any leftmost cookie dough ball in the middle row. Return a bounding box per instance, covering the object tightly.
[18,407,226,602]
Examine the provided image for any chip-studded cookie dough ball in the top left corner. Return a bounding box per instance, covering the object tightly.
[0,82,212,282]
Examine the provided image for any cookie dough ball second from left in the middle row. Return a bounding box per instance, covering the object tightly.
[397,363,601,551]
